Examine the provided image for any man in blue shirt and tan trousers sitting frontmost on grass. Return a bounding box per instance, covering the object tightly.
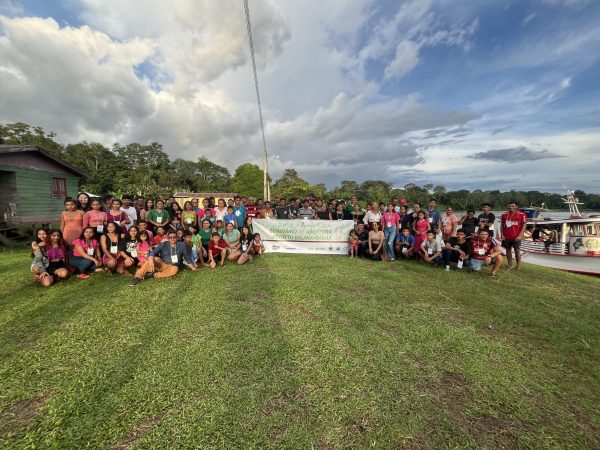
[129,231,197,286]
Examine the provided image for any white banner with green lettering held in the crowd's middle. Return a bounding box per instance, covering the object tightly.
[253,219,354,255]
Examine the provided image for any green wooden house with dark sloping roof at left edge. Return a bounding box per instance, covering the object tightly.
[0,145,86,225]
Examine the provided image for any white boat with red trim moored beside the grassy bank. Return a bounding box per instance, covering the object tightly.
[496,186,600,276]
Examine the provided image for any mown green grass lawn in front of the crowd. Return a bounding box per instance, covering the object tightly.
[0,251,600,449]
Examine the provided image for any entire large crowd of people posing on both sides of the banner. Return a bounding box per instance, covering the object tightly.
[31,193,527,286]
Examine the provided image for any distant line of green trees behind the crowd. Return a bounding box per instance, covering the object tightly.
[0,123,600,210]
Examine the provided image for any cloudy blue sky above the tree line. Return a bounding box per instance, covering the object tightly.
[0,0,600,192]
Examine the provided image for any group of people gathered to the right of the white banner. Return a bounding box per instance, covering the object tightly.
[348,199,527,277]
